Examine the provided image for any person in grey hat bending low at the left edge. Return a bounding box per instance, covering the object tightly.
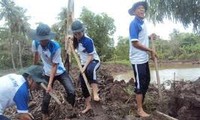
[0,65,43,120]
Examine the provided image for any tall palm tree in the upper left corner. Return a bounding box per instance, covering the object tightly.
[0,0,30,69]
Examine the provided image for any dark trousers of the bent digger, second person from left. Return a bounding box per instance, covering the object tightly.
[42,71,75,114]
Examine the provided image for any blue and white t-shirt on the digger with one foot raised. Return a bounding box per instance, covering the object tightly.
[77,35,100,65]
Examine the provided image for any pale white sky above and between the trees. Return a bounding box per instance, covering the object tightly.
[14,0,192,43]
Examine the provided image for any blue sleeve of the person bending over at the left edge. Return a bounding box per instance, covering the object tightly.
[13,82,29,113]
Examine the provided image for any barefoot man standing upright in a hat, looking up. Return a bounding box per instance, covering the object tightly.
[128,2,157,117]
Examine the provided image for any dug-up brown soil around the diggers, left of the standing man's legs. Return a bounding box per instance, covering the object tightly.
[5,65,153,120]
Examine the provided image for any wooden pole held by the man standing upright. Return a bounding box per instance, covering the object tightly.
[150,35,163,101]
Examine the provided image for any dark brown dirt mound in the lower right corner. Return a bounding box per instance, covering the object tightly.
[166,78,200,120]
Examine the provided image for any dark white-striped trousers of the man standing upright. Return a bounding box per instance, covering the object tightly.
[132,62,150,101]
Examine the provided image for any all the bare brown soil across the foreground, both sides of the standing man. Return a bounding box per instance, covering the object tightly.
[5,64,200,120]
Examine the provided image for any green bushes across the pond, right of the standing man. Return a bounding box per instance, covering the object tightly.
[155,32,200,60]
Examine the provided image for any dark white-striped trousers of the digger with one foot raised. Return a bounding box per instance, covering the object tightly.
[79,60,100,98]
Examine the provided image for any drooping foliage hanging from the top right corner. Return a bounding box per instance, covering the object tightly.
[146,0,200,32]
